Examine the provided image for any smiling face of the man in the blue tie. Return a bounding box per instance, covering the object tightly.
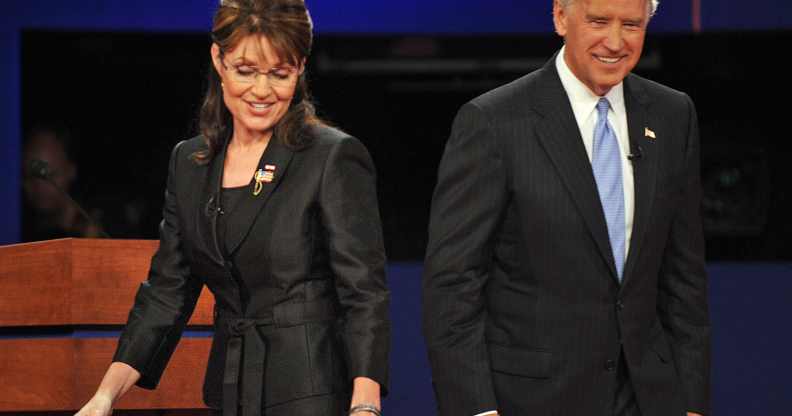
[553,0,649,96]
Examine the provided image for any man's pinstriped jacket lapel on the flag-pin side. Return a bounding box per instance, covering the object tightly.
[624,75,658,284]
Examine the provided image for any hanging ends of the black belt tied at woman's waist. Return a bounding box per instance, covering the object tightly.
[223,319,274,416]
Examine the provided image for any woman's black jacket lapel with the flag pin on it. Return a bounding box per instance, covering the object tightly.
[226,138,294,254]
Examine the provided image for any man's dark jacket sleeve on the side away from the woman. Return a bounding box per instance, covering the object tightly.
[658,96,710,415]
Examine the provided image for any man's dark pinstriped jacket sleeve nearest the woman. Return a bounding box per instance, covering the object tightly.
[423,103,508,416]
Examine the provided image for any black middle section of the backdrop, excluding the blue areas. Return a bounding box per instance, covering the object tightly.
[17,31,792,261]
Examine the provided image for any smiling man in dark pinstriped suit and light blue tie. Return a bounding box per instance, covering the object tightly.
[424,0,710,416]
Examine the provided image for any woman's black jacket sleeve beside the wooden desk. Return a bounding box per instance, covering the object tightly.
[113,143,203,389]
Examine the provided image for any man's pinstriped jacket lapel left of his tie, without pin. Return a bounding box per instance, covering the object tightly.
[535,57,617,279]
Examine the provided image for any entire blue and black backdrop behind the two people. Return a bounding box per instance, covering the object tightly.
[0,0,792,415]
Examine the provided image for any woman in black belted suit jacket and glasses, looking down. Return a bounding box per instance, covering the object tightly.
[78,0,390,416]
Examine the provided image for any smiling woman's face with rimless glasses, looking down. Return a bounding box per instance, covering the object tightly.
[212,35,304,141]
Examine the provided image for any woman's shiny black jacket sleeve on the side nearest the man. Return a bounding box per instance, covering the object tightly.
[319,137,390,394]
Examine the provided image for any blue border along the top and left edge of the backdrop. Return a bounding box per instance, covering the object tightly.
[0,0,792,243]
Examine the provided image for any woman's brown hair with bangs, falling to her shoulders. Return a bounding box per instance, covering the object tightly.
[193,0,324,163]
